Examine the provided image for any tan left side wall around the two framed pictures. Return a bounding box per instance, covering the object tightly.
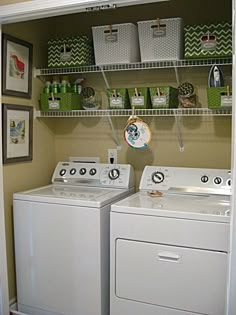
[2,23,55,299]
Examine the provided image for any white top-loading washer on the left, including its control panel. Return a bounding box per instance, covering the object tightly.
[14,162,134,315]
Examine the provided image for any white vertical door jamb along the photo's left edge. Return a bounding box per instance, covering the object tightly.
[0,24,9,315]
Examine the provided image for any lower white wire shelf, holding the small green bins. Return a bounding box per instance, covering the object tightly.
[35,108,232,118]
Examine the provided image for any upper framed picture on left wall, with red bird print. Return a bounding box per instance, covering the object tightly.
[2,34,33,98]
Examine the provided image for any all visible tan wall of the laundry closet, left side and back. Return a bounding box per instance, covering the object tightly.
[1,0,231,298]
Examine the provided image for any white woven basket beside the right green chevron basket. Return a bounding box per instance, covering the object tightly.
[138,18,184,62]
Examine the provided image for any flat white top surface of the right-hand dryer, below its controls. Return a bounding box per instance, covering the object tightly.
[111,191,230,222]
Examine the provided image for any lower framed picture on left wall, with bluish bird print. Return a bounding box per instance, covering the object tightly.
[2,104,33,164]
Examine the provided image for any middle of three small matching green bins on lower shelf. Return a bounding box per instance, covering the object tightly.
[128,87,151,109]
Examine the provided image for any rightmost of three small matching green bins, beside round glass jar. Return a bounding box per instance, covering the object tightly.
[149,86,179,108]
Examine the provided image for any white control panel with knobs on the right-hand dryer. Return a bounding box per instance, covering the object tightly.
[139,166,231,194]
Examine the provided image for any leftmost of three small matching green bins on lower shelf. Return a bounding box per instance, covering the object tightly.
[107,88,130,109]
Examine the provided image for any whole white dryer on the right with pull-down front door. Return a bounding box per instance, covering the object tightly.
[110,166,231,315]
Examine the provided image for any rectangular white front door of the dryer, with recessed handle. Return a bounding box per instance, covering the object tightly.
[115,239,227,315]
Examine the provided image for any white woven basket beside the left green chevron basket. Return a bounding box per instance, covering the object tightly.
[92,23,140,65]
